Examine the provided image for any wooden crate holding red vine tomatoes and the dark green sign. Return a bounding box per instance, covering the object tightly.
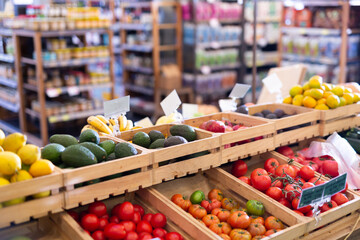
[218,152,360,237]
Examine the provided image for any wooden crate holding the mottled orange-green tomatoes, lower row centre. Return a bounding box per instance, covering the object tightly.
[139,171,305,240]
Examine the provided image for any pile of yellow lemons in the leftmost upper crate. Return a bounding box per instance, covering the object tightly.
[0,129,54,208]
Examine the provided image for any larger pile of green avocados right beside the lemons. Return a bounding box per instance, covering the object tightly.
[41,129,137,168]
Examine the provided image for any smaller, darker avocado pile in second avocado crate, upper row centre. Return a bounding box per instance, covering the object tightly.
[132,125,197,149]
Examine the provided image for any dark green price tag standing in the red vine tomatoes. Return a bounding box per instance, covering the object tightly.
[298,173,347,208]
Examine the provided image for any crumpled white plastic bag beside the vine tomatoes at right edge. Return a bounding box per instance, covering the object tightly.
[301,132,360,189]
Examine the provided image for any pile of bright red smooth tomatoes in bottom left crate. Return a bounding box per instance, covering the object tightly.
[68,202,183,240]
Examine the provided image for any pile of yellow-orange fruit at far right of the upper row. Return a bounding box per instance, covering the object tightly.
[283,75,360,110]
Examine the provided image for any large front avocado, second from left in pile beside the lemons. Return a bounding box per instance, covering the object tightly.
[61,145,97,168]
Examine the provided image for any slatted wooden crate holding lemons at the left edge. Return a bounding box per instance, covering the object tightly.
[0,167,64,228]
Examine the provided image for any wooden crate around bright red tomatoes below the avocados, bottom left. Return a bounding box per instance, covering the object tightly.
[50,192,192,240]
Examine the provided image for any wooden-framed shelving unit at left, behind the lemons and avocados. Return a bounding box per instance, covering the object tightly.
[13,29,114,146]
